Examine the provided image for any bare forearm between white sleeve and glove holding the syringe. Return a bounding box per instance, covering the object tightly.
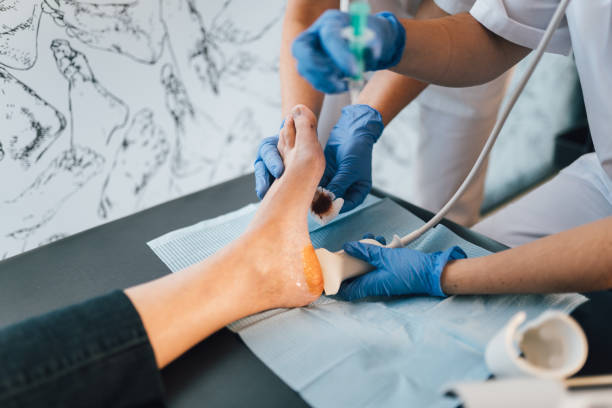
[392,13,531,87]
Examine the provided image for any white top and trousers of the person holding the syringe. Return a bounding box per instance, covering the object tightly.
[470,0,612,246]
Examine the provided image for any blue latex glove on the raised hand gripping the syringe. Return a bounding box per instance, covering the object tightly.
[291,10,406,93]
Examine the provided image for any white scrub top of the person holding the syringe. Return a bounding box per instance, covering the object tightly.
[470,0,612,186]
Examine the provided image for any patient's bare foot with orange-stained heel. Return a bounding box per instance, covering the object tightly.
[220,105,325,310]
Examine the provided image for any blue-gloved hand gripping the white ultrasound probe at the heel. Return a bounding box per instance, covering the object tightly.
[338,235,467,300]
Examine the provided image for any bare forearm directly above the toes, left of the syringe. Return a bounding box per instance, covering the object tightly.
[280,0,339,117]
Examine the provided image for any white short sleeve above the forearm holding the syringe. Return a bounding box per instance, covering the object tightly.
[470,0,572,55]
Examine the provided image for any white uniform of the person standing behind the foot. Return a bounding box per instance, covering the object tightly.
[319,0,510,226]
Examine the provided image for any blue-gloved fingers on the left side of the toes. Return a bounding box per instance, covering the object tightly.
[253,120,285,200]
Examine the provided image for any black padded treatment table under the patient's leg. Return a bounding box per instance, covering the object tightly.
[0,175,612,407]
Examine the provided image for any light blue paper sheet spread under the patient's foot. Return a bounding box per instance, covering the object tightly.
[149,197,585,407]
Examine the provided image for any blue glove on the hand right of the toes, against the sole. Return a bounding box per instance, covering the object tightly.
[320,105,384,212]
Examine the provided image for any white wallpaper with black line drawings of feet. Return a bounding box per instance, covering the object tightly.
[0,0,284,259]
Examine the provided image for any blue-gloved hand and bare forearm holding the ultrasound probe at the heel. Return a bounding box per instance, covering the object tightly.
[338,217,612,300]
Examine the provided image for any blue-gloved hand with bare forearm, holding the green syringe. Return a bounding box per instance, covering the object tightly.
[292,6,529,93]
